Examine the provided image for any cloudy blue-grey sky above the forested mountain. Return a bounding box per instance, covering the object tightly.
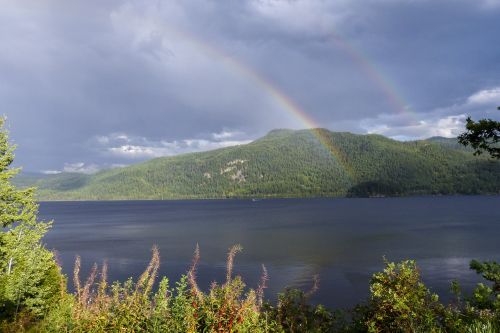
[0,0,500,173]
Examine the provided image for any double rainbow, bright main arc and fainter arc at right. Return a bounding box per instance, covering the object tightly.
[154,24,410,182]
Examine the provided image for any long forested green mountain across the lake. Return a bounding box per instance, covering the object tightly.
[16,129,500,200]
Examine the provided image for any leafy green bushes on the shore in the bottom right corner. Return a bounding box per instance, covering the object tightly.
[348,260,500,333]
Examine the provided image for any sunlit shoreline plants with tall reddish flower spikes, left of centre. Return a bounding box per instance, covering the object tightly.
[28,246,281,332]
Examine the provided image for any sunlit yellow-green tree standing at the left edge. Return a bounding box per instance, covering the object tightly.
[0,118,65,320]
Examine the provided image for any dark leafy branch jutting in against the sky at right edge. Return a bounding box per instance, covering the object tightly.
[458,106,500,159]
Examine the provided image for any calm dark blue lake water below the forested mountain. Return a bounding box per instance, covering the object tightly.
[40,196,500,307]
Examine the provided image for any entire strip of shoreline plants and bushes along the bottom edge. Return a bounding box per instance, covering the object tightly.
[4,245,500,333]
